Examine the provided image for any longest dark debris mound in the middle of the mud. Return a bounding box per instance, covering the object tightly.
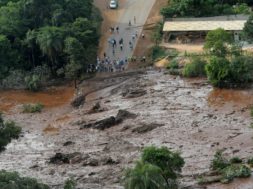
[80,110,137,130]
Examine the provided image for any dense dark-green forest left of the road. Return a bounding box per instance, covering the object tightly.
[0,0,101,89]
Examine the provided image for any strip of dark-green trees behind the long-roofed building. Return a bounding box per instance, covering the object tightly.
[161,0,253,18]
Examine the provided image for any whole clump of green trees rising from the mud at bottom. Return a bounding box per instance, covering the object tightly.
[124,146,184,189]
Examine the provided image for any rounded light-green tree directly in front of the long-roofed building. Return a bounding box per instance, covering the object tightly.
[204,28,233,57]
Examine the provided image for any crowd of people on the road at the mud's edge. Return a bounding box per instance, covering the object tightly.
[95,16,146,72]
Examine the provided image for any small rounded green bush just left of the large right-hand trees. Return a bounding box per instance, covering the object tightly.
[183,57,206,77]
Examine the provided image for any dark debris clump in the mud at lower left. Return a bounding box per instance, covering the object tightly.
[49,152,82,164]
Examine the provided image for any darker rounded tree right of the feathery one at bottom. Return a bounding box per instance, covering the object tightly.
[141,146,184,180]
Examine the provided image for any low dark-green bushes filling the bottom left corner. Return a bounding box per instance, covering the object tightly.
[0,170,49,189]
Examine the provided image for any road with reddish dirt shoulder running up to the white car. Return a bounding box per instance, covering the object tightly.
[95,0,155,67]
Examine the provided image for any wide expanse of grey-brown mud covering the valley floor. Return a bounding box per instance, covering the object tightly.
[0,70,253,189]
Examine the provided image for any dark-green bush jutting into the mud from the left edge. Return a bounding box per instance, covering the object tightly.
[0,114,21,151]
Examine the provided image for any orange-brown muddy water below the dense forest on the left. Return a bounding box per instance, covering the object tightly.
[0,87,74,112]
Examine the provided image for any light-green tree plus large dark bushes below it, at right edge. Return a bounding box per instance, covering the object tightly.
[204,29,253,87]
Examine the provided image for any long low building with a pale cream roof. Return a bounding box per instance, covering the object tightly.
[163,15,248,43]
